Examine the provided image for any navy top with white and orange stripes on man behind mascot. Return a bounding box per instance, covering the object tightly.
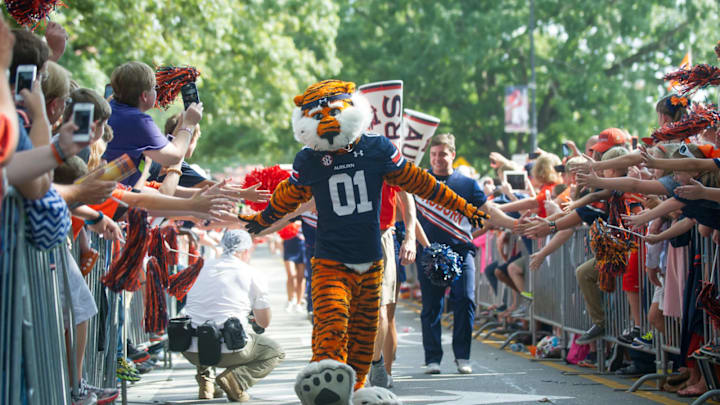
[415,171,487,250]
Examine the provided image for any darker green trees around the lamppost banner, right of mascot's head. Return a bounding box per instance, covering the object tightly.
[337,0,718,171]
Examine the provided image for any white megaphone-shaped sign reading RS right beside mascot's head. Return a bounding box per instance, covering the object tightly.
[358,80,403,146]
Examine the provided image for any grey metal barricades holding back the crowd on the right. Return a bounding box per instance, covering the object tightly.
[476,223,704,380]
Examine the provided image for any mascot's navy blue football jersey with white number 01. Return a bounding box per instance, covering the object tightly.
[290,134,406,264]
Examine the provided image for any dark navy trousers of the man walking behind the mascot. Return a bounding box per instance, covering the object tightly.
[418,250,475,364]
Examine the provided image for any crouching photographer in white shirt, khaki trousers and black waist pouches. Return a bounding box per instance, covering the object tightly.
[168,230,285,402]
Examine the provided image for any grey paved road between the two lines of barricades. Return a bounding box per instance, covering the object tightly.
[127,247,690,405]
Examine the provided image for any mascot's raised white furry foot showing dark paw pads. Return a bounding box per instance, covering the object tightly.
[295,359,355,405]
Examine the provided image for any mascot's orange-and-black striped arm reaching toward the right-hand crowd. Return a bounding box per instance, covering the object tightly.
[384,162,489,227]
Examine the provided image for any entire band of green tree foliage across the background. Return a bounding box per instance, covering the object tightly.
[5,0,720,171]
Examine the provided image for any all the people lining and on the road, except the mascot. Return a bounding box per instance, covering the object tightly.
[0,9,720,404]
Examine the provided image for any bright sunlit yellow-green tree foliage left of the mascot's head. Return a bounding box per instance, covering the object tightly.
[6,0,340,164]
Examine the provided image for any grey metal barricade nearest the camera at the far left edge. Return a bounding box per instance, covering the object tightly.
[0,189,70,404]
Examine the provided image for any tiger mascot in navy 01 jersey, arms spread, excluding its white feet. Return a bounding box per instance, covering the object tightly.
[239,80,488,404]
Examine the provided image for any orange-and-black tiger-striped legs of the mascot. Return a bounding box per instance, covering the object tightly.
[311,258,383,390]
